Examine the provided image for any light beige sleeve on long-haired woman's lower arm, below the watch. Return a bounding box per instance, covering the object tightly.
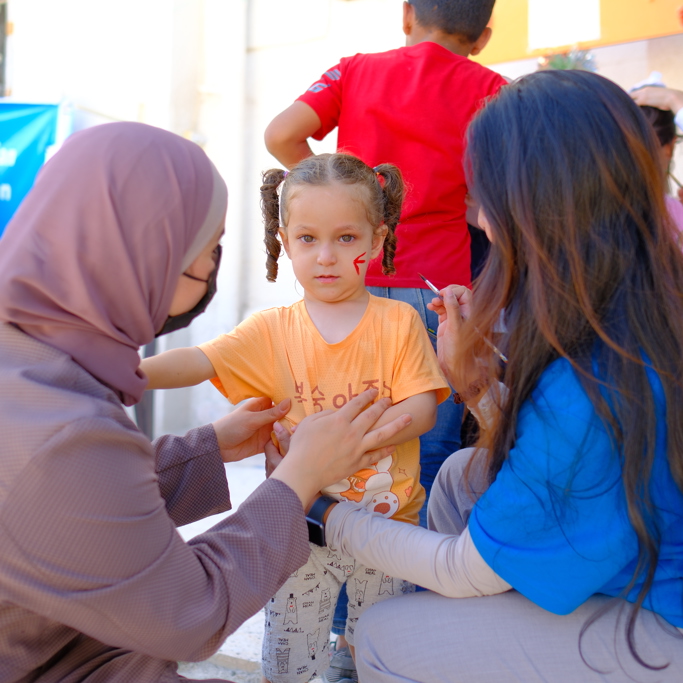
[325,503,512,598]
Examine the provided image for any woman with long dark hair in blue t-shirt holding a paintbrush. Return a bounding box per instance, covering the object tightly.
[302,71,683,683]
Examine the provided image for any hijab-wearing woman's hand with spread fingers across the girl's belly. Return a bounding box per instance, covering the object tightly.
[266,389,412,509]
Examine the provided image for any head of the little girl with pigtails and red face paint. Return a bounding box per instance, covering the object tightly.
[261,154,404,303]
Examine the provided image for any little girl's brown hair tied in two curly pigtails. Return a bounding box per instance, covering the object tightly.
[261,154,404,282]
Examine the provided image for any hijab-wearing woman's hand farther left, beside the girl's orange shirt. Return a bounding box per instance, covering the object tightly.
[213,398,291,462]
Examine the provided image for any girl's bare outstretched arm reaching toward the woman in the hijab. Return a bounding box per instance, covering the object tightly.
[140,346,216,389]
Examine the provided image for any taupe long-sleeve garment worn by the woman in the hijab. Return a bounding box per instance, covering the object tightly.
[0,324,309,683]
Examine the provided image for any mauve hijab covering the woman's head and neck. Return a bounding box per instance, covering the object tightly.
[0,123,227,405]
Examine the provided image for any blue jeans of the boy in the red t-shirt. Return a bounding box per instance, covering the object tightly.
[332,287,464,635]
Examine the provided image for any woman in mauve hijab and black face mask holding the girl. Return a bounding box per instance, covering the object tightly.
[0,123,409,683]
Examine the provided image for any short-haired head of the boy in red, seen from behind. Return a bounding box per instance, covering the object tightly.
[403,0,495,54]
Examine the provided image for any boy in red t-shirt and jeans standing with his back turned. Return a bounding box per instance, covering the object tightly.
[265,0,506,680]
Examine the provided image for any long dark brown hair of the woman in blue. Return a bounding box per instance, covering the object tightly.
[459,71,683,668]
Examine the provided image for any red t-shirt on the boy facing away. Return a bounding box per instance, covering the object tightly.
[299,42,505,288]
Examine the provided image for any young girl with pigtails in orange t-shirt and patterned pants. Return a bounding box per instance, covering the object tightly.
[142,154,449,683]
